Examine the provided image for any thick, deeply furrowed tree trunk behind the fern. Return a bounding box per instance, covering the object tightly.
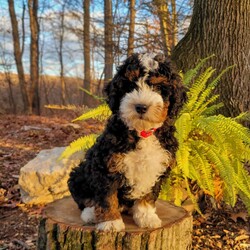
[172,0,250,119]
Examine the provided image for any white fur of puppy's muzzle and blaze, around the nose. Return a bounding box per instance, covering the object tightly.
[120,78,164,131]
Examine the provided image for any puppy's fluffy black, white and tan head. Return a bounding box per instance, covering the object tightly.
[105,54,186,131]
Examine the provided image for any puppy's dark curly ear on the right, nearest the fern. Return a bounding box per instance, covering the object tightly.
[168,74,187,119]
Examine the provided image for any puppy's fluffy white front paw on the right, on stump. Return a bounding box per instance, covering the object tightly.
[133,201,161,228]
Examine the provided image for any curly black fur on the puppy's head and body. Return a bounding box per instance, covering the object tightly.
[68,54,186,219]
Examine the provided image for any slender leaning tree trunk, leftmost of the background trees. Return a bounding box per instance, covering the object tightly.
[8,0,29,112]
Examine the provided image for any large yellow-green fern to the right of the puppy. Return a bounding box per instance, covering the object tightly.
[162,61,250,212]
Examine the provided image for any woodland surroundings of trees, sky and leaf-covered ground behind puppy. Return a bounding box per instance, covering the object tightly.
[0,0,250,249]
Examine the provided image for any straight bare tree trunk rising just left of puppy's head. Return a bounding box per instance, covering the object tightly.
[104,0,114,83]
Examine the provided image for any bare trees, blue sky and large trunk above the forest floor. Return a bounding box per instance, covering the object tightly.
[0,0,250,119]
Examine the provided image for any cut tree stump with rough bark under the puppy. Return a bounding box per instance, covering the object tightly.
[38,197,192,250]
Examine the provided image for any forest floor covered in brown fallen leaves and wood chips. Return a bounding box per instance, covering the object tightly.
[0,115,250,250]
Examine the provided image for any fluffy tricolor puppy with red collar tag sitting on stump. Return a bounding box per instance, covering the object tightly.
[68,54,186,231]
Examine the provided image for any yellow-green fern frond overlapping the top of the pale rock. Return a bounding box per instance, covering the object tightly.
[59,134,98,159]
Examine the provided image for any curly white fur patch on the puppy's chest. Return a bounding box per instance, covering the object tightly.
[121,135,171,199]
